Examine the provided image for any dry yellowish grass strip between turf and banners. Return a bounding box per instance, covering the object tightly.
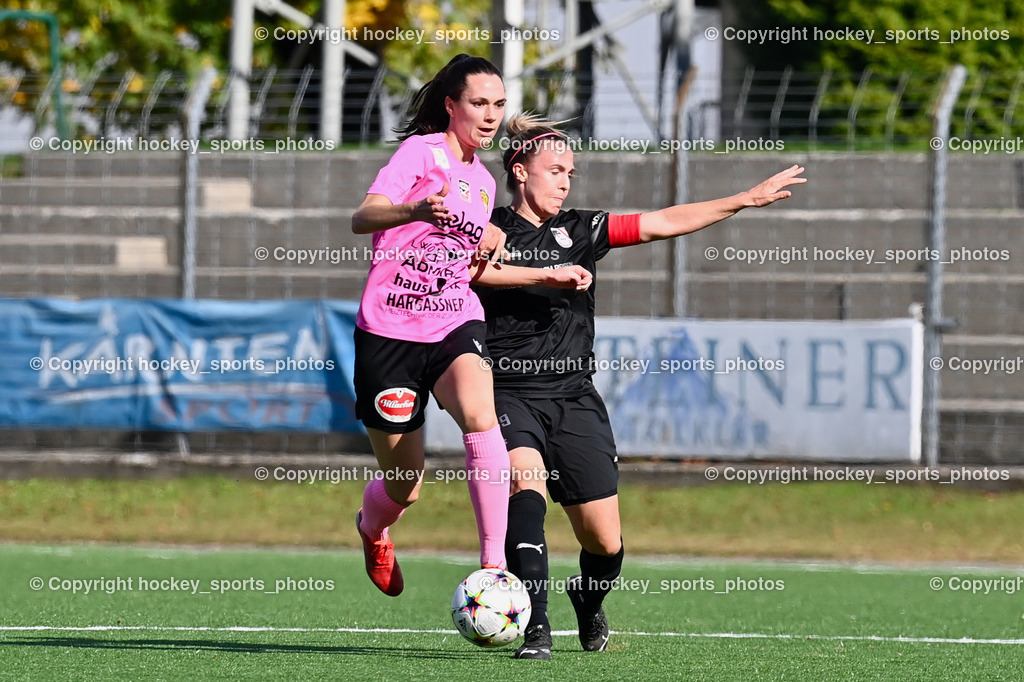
[6,476,1024,564]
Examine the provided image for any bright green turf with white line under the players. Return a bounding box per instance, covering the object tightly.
[0,544,1024,682]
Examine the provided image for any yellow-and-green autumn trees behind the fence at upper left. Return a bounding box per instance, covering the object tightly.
[0,0,512,139]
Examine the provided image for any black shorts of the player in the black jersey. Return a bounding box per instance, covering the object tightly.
[495,386,618,506]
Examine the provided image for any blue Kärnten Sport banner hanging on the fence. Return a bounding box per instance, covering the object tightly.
[0,299,362,432]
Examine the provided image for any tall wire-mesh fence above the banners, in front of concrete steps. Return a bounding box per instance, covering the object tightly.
[0,65,1024,464]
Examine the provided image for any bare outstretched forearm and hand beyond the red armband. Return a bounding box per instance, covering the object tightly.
[639,166,807,243]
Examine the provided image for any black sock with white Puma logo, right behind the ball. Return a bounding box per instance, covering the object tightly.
[505,491,548,625]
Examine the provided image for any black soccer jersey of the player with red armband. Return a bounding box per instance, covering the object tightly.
[474,207,611,397]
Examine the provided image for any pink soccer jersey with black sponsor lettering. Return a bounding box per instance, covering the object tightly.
[355,133,495,342]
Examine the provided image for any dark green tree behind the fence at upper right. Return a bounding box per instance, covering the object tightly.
[739,0,1024,136]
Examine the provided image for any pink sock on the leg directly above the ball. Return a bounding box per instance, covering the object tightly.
[462,426,511,568]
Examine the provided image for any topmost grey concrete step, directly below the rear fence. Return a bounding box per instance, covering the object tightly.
[16,147,1024,210]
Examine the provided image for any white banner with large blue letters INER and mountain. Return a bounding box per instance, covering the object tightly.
[427,317,923,462]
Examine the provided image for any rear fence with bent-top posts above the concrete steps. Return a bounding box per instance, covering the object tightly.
[12,62,1024,151]
